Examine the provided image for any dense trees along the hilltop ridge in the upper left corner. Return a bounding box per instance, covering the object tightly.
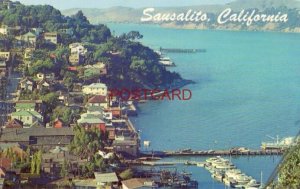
[0,4,111,43]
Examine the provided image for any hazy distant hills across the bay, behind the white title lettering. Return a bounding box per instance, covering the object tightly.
[62,0,300,32]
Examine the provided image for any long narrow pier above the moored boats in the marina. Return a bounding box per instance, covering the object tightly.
[140,149,284,158]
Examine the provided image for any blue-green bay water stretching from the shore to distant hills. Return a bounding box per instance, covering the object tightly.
[109,24,300,188]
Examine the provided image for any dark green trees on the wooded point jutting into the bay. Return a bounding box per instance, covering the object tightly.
[94,34,181,88]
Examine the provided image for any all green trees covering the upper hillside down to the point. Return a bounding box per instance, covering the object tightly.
[0,1,181,89]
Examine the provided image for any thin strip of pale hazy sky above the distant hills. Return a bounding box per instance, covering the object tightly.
[19,0,233,10]
